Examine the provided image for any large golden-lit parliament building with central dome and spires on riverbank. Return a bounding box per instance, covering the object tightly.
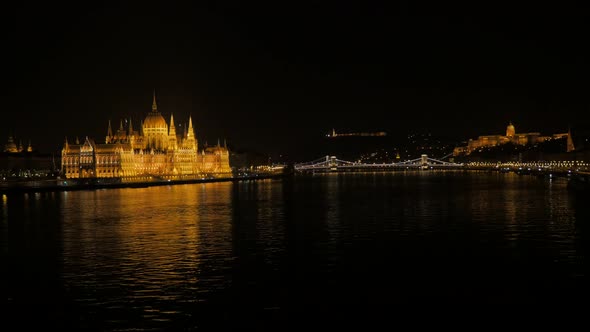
[62,93,231,178]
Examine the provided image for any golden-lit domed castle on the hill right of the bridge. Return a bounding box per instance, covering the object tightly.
[453,122,574,156]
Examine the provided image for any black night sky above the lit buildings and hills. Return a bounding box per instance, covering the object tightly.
[0,1,590,160]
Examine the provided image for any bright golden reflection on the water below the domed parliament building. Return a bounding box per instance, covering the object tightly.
[62,182,232,308]
